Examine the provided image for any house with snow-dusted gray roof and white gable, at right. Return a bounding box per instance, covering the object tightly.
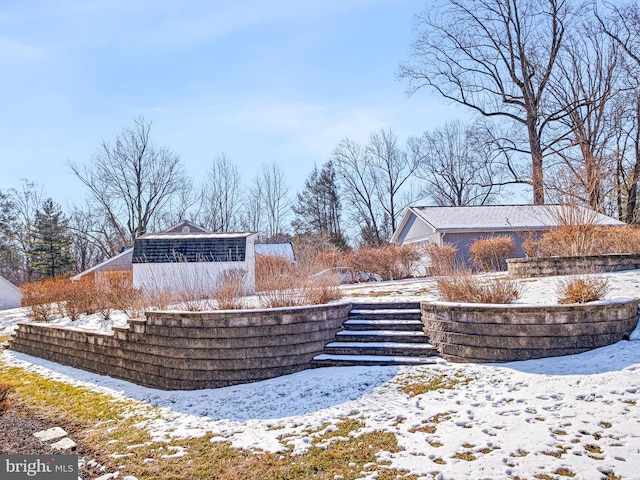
[391,205,624,262]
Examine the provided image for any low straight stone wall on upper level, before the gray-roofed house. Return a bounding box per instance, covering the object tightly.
[507,254,640,278]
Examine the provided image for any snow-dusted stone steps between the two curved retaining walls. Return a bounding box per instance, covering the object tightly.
[312,302,438,367]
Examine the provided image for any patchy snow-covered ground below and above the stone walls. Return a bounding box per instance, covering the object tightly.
[0,271,640,480]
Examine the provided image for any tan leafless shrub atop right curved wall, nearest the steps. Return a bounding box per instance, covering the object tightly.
[436,270,523,304]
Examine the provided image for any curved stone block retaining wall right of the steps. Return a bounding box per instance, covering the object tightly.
[421,298,640,363]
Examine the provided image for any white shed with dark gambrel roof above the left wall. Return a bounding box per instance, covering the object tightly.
[132,232,258,293]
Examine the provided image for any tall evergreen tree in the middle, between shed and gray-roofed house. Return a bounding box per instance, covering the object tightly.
[292,161,347,248]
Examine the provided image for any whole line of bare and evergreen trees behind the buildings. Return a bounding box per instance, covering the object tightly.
[0,0,640,284]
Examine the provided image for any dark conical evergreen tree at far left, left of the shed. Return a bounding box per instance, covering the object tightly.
[29,198,73,278]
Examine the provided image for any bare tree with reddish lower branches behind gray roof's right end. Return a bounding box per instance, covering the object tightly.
[549,19,622,211]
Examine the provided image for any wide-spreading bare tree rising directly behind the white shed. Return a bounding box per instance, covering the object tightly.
[70,117,190,245]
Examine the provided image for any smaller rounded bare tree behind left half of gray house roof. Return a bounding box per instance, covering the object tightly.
[416,121,501,206]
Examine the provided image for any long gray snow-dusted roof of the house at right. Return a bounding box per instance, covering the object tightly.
[411,205,624,231]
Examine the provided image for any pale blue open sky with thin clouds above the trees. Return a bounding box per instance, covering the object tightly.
[0,0,463,206]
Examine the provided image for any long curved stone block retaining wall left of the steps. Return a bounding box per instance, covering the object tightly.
[9,304,351,390]
